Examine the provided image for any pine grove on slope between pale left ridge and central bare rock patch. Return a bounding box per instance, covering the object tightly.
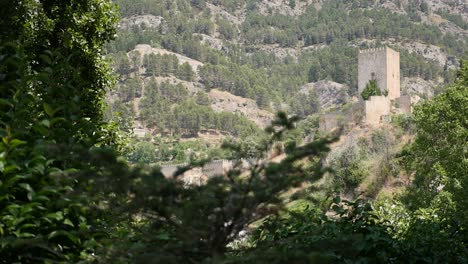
[136,80,260,137]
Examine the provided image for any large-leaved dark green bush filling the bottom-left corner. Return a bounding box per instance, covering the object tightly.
[0,135,97,263]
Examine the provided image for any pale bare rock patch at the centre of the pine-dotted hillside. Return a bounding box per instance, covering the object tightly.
[208,89,274,127]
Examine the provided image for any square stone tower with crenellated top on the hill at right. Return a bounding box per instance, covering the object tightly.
[358,47,400,100]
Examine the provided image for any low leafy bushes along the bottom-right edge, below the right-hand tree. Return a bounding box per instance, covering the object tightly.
[239,197,468,263]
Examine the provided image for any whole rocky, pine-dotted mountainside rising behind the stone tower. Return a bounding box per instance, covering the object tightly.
[108,0,468,140]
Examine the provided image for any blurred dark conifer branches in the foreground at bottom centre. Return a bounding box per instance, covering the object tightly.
[98,114,330,263]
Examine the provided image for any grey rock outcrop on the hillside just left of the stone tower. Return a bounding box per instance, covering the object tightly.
[299,80,350,112]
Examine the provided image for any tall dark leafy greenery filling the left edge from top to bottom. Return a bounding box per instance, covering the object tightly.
[0,0,117,263]
